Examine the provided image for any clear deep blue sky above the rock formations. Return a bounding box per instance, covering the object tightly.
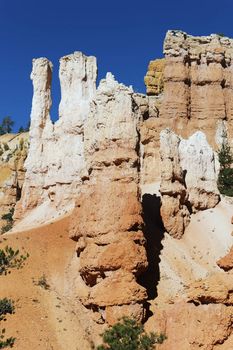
[0,0,233,130]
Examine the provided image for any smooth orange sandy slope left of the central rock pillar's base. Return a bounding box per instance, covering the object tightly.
[0,217,90,350]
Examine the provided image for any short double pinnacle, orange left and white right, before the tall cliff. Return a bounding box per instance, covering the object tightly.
[160,129,220,238]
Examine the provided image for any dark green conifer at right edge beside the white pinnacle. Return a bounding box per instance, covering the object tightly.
[217,135,233,197]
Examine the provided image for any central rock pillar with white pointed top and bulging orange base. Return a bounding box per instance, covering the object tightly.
[70,74,147,324]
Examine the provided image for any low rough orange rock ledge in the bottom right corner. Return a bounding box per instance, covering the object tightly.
[146,302,233,350]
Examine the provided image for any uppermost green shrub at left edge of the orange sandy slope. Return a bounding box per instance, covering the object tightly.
[0,246,29,275]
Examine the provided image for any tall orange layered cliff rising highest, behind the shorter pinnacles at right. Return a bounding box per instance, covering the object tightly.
[141,31,233,184]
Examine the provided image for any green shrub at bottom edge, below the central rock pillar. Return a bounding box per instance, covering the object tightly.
[97,317,166,350]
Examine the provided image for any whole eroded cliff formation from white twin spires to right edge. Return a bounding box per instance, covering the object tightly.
[10,31,233,350]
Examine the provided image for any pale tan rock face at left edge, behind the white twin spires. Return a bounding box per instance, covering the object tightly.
[0,133,28,227]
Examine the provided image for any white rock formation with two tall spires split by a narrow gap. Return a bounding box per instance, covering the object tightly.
[15,52,97,226]
